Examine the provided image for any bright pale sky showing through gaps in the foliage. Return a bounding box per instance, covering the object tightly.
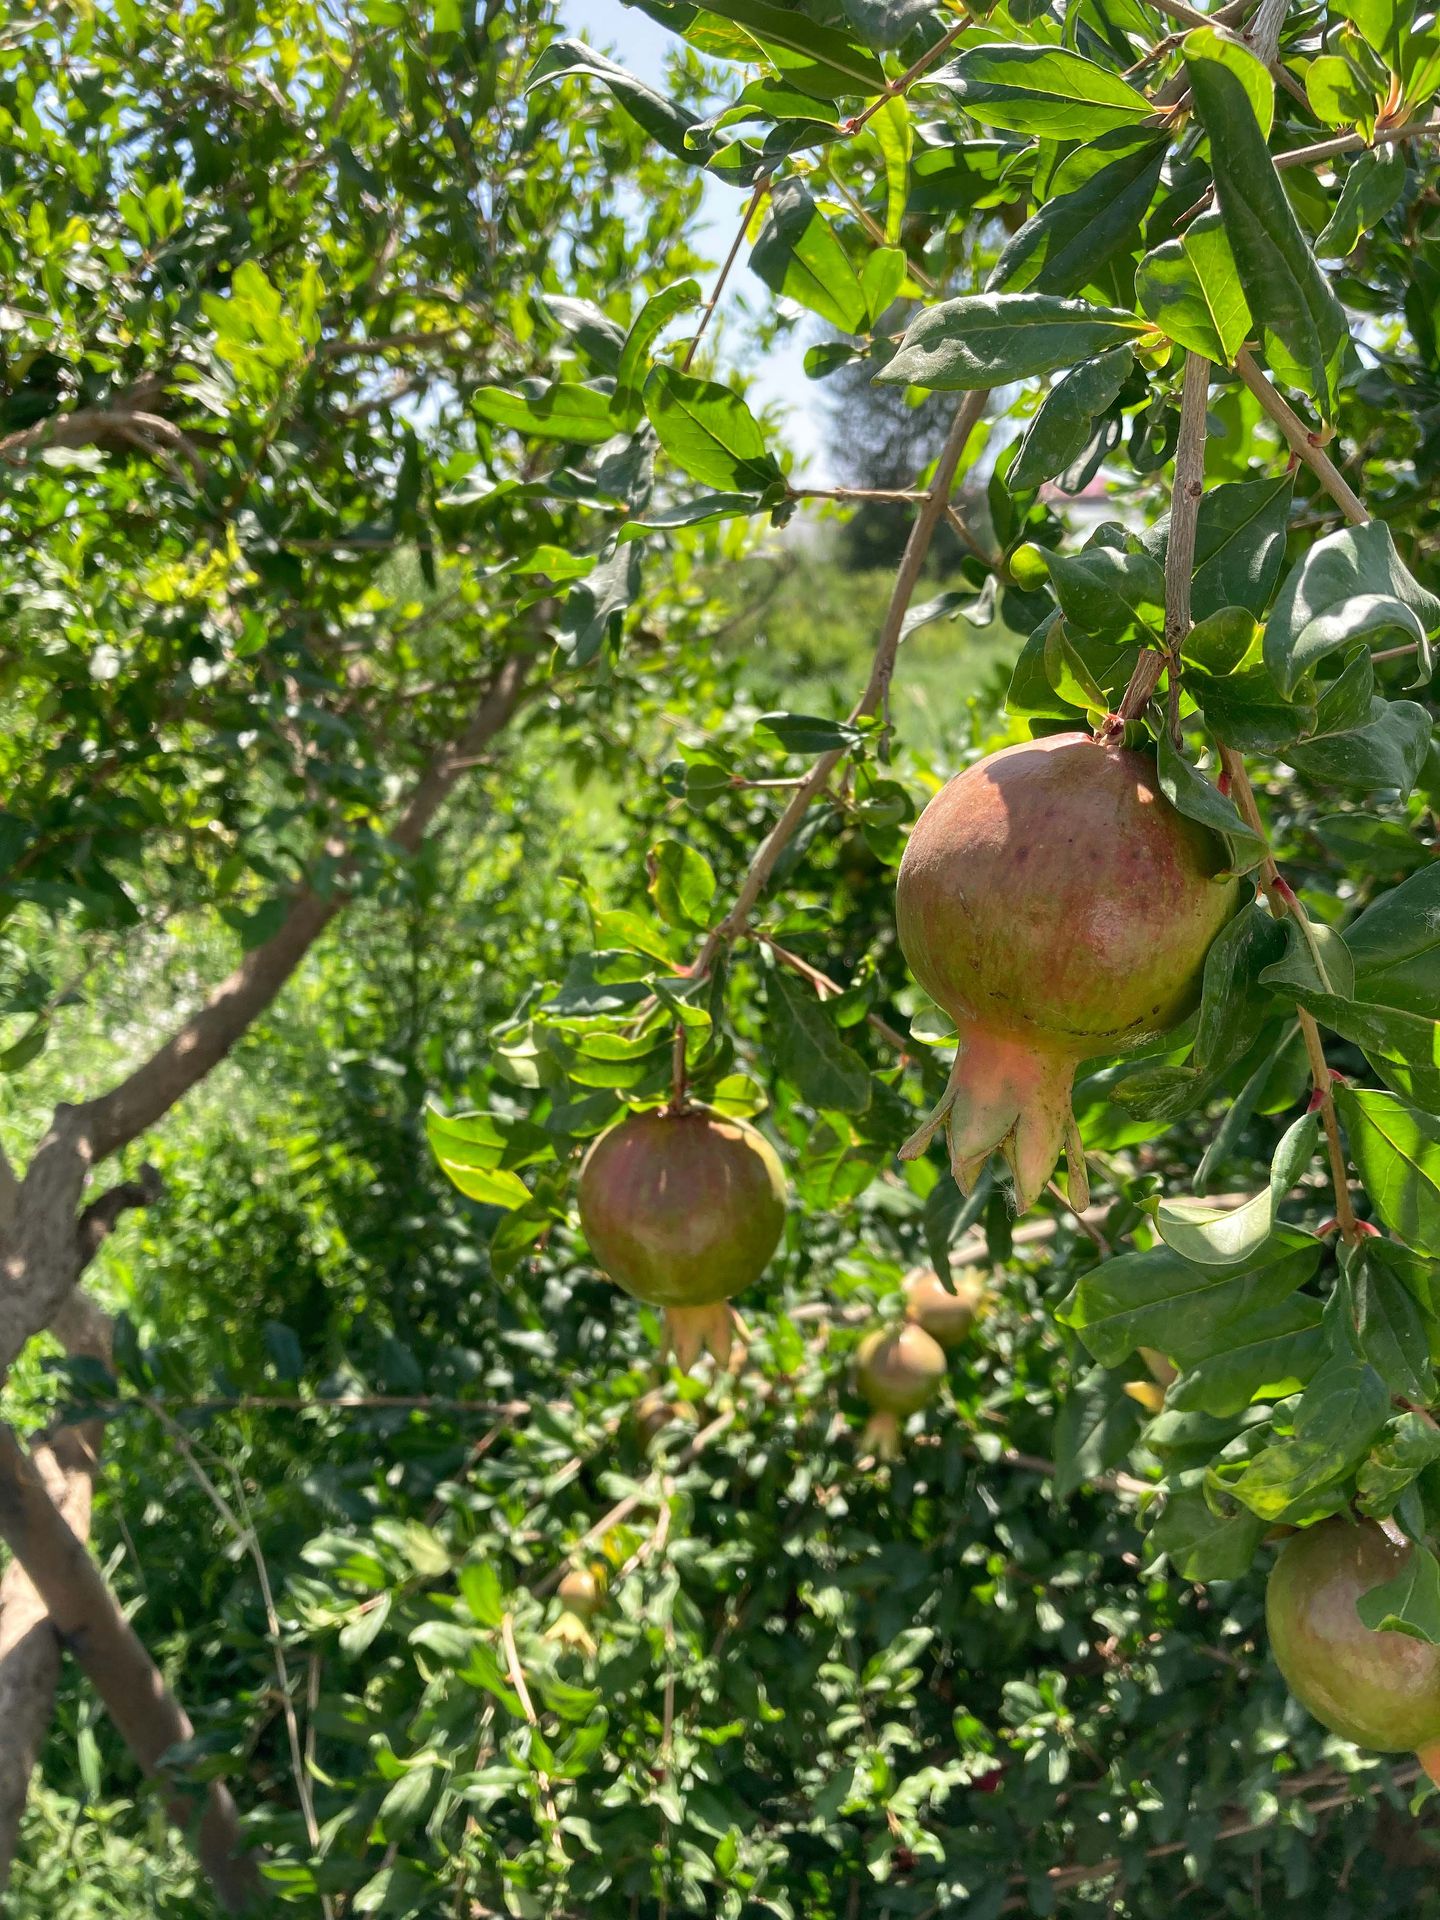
[559,0,828,486]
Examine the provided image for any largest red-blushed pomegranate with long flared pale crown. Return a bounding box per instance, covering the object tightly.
[895,733,1236,1212]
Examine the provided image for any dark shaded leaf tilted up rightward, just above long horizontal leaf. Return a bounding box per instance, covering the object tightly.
[985,131,1167,294]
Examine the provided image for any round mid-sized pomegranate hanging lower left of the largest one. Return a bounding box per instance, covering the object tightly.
[580,1106,785,1369]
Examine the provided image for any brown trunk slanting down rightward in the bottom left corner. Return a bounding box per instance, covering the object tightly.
[0,1427,263,1912]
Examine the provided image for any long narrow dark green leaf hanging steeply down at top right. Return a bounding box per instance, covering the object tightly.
[1185,27,1350,419]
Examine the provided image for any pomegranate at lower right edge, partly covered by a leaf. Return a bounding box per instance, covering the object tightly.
[1265,1519,1440,1778]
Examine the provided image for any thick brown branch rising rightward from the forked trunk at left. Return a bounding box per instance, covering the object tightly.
[80,657,526,1159]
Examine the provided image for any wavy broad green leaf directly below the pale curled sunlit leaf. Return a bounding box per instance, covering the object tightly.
[1056,1227,1321,1367]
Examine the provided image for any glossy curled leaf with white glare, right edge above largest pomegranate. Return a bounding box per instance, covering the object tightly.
[1265,520,1440,693]
